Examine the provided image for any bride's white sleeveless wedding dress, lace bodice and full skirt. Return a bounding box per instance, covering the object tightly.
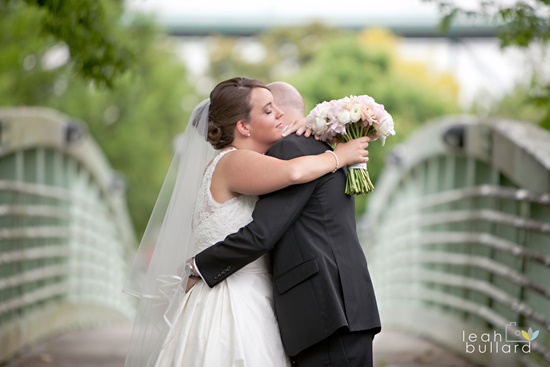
[155,150,290,367]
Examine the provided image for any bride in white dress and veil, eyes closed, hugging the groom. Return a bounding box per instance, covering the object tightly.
[125,78,368,367]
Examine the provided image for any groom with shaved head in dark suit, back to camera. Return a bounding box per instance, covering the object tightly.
[195,82,380,367]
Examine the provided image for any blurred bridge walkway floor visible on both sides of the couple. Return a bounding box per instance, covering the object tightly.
[3,324,474,367]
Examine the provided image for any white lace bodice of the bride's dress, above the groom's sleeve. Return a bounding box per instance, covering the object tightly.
[193,149,258,252]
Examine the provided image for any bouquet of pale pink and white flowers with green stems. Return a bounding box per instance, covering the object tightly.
[307,95,395,195]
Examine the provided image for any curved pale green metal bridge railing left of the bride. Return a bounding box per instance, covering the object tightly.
[0,108,135,362]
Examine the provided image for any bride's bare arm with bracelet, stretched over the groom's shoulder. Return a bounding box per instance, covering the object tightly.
[216,137,369,195]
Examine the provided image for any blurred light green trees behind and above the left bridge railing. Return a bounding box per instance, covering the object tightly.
[0,7,199,239]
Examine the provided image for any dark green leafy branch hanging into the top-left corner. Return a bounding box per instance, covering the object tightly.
[0,0,134,87]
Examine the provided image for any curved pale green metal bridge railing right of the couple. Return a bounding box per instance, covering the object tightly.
[362,116,550,366]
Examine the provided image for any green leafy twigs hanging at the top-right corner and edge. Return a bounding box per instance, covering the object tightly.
[423,0,550,129]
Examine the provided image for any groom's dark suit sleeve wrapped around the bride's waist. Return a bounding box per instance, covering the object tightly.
[195,139,318,287]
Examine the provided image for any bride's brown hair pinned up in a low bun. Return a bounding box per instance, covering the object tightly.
[208,78,268,149]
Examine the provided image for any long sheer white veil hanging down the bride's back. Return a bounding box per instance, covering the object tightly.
[124,99,216,367]
